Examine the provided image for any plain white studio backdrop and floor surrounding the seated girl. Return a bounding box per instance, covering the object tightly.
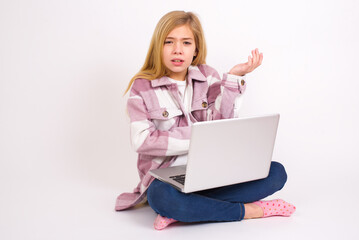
[0,0,359,239]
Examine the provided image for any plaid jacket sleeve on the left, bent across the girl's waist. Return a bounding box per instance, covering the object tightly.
[127,80,191,156]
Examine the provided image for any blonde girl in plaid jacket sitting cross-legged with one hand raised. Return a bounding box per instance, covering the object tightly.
[116,11,295,229]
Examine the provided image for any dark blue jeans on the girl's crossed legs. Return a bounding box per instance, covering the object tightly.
[147,162,287,222]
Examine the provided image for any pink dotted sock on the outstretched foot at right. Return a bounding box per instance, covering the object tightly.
[254,199,295,217]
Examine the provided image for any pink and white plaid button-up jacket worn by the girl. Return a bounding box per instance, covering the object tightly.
[115,65,246,211]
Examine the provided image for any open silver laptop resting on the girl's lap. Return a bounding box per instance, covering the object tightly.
[150,114,279,193]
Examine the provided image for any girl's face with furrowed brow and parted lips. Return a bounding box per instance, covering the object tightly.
[162,25,197,81]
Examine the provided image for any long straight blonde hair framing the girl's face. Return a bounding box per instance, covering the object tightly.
[125,11,207,94]
